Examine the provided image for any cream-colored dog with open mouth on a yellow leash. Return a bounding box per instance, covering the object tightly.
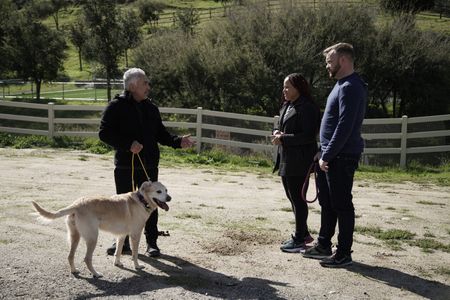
[32,181,171,277]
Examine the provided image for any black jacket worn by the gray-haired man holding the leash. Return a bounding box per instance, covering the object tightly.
[99,92,181,169]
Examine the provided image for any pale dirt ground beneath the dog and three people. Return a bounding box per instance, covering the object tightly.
[0,149,450,300]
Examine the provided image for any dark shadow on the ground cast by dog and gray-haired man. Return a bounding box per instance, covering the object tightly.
[75,255,287,299]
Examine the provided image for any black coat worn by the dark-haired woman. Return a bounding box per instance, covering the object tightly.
[274,97,320,177]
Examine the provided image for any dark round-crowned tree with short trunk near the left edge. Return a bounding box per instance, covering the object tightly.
[10,15,66,100]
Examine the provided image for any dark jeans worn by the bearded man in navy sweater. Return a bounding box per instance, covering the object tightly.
[317,154,359,255]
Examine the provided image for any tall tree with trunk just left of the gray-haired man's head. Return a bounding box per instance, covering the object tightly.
[83,0,127,100]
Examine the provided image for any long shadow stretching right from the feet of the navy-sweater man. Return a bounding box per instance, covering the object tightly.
[347,262,450,300]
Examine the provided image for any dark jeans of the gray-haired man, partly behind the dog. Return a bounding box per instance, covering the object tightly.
[114,168,158,244]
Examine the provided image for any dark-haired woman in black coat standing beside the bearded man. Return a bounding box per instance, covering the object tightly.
[272,73,320,253]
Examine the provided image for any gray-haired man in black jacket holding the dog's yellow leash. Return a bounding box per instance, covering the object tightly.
[99,68,194,257]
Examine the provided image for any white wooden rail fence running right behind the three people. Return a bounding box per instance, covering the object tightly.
[0,101,450,167]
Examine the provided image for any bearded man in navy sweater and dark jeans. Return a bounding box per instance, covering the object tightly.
[304,43,367,267]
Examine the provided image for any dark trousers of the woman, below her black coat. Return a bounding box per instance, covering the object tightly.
[281,176,309,243]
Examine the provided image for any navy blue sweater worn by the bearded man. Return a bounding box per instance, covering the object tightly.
[320,73,367,162]
